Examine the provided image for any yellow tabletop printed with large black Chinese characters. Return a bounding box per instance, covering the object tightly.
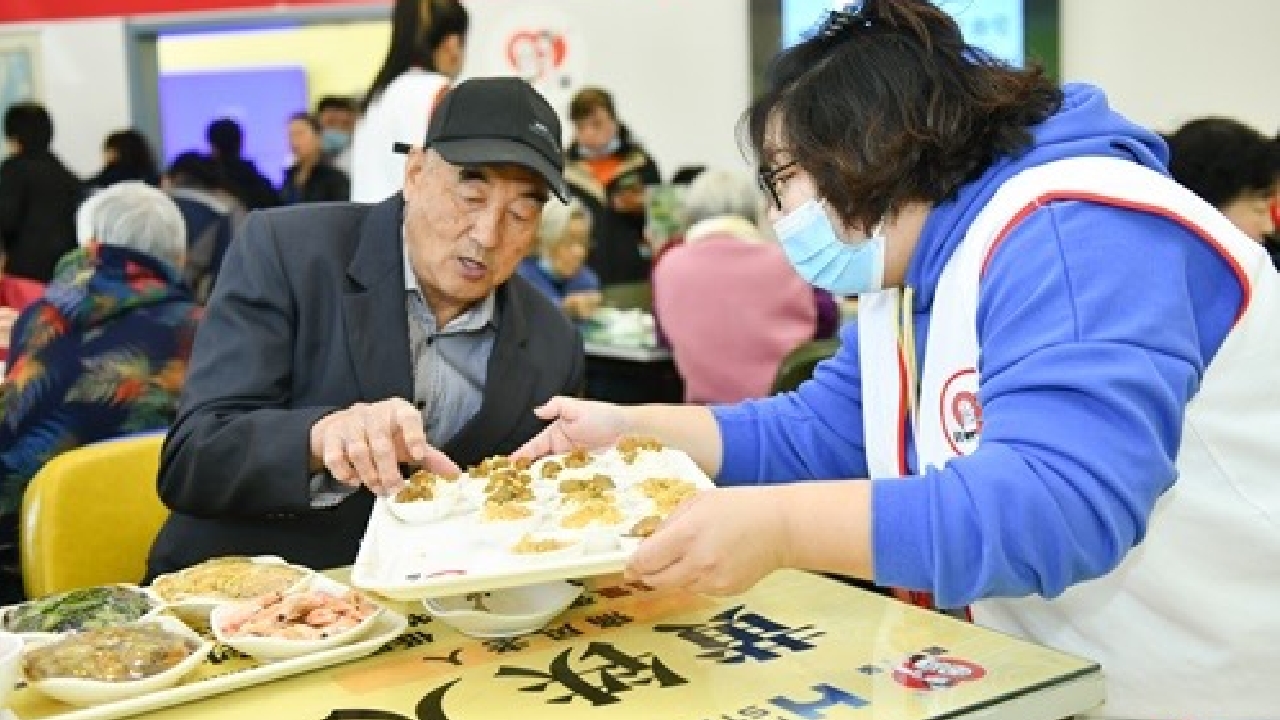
[7,571,1102,720]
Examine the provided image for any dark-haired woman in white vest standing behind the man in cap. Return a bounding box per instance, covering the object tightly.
[351,0,471,202]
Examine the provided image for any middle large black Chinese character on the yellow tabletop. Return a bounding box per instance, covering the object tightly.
[495,642,687,706]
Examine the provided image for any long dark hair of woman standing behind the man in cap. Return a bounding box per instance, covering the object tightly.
[360,0,471,110]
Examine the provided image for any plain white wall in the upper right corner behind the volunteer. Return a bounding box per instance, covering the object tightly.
[1061,0,1280,136]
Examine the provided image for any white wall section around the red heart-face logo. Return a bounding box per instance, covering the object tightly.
[466,0,751,178]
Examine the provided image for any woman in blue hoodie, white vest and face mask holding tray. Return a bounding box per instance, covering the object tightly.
[516,0,1280,720]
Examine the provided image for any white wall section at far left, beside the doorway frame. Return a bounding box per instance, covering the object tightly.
[0,19,129,177]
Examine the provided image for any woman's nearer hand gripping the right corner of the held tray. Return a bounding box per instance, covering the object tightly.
[626,487,791,596]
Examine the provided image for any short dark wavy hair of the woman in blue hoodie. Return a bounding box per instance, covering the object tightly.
[739,0,1062,228]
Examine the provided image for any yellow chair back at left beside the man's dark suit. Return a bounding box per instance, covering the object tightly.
[18,434,169,597]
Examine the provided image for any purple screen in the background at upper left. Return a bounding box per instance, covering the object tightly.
[160,67,307,187]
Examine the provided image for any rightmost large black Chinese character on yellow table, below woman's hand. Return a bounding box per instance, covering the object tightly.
[654,605,824,665]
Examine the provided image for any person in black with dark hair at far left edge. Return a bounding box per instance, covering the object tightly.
[0,102,84,283]
